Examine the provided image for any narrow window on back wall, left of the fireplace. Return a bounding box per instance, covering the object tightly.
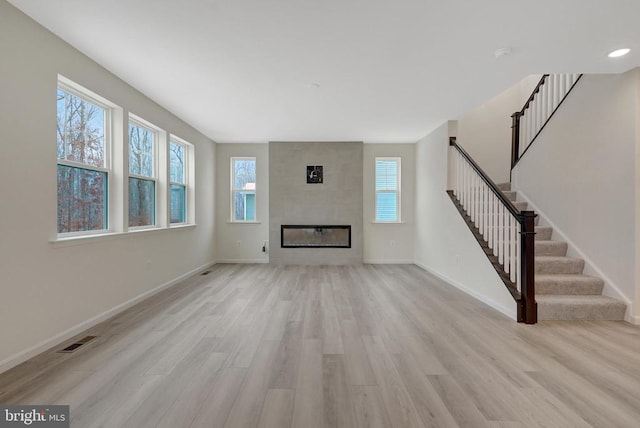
[231,158,256,221]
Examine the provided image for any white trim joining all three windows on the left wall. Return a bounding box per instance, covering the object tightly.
[50,75,196,247]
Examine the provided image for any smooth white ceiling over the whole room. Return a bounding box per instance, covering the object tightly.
[9,0,640,142]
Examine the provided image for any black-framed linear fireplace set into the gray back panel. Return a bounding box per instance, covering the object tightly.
[280,224,351,248]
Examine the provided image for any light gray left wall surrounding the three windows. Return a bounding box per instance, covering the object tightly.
[0,0,216,372]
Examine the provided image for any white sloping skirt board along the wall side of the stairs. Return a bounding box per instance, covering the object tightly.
[512,189,640,324]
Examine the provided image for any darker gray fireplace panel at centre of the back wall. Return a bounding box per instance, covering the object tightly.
[269,142,363,264]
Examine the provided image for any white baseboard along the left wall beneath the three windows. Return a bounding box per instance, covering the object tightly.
[0,262,216,373]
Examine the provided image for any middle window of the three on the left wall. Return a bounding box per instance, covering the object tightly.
[129,116,157,227]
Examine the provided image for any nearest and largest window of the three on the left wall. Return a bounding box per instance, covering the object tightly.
[56,81,111,234]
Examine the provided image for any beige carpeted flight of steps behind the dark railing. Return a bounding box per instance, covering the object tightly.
[498,183,627,320]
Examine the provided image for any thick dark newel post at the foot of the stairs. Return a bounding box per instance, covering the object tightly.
[518,211,538,324]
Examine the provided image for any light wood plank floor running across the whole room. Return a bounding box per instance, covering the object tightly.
[0,265,640,428]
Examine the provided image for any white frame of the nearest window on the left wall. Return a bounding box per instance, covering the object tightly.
[56,75,118,239]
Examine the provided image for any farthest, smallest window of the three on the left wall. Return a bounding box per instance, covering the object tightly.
[169,137,187,223]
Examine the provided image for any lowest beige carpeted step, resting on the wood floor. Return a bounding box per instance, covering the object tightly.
[536,295,627,321]
